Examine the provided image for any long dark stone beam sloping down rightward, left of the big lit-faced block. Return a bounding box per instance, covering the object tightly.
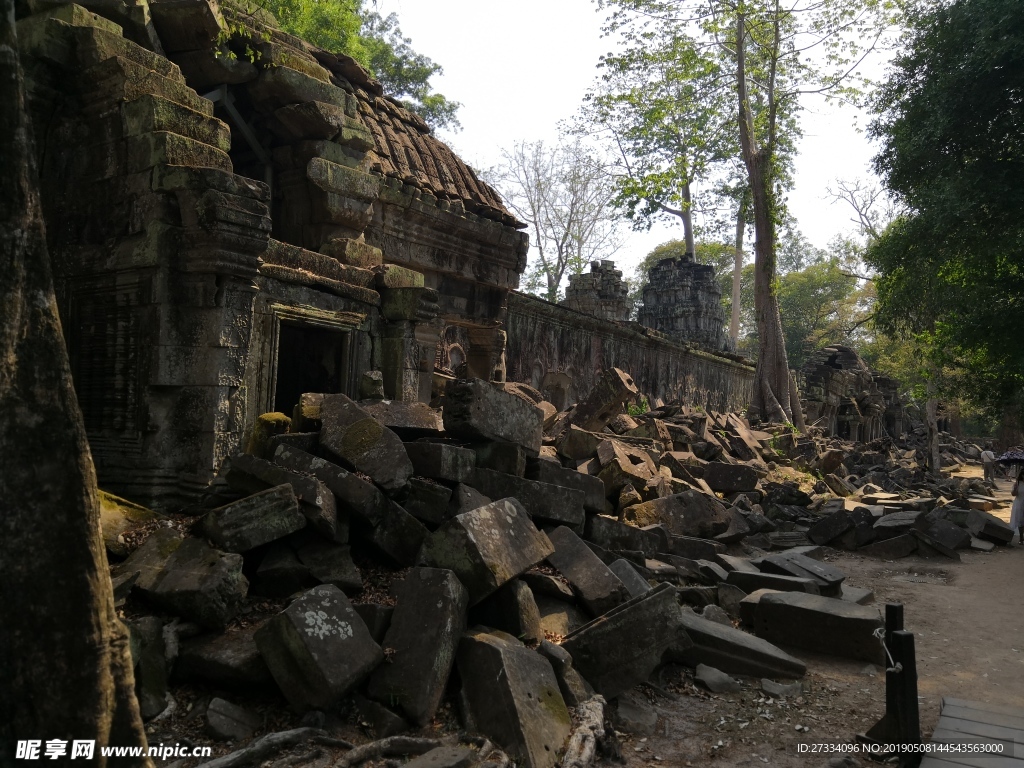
[273,445,427,565]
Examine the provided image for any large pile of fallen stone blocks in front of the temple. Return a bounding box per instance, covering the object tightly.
[104,369,1010,768]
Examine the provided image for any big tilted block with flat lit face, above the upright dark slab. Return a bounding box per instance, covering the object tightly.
[421,499,554,605]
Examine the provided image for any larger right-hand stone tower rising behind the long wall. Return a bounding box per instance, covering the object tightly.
[637,254,726,350]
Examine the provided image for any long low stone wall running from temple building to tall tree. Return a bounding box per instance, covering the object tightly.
[505,293,754,412]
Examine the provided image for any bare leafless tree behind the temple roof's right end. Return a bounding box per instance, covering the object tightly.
[484,139,622,301]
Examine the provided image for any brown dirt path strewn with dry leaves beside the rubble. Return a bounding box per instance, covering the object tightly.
[623,468,1024,768]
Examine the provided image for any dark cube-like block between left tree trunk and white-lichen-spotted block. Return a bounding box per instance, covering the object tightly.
[144,539,249,630]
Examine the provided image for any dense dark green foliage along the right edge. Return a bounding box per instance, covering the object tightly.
[866,0,1024,417]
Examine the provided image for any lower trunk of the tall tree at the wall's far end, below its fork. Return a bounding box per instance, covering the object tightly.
[748,152,793,422]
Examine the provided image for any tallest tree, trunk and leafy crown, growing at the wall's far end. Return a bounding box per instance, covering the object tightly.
[604,0,889,421]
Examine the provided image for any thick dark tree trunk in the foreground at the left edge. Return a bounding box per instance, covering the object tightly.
[0,0,152,766]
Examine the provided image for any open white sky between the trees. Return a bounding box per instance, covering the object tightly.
[371,0,872,274]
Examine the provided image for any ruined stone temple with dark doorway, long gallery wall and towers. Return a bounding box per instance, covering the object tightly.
[17,0,905,507]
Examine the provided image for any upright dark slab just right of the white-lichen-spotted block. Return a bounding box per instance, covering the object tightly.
[368,568,469,726]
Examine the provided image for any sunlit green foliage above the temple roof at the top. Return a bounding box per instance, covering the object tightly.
[258,0,460,129]
